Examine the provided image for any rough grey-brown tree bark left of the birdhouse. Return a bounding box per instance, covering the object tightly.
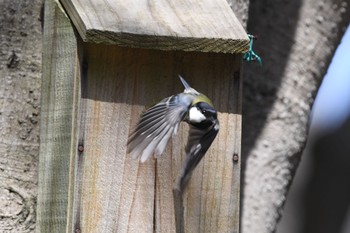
[0,0,41,232]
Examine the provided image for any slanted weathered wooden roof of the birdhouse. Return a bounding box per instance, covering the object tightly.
[61,0,249,53]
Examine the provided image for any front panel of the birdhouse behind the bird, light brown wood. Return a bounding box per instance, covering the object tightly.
[74,44,242,232]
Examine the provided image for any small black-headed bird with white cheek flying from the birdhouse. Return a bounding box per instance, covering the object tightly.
[127,75,219,192]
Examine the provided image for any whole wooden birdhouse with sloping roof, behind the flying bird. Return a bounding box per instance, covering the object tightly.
[36,0,249,233]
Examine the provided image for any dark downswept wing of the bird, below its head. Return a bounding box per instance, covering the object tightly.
[176,120,220,192]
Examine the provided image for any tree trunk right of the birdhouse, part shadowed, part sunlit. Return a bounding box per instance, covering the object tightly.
[242,0,350,233]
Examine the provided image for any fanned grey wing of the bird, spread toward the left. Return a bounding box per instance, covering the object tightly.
[128,94,192,162]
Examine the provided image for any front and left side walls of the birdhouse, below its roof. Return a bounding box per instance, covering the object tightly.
[37,0,242,233]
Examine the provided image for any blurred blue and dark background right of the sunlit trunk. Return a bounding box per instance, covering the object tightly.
[277,26,350,233]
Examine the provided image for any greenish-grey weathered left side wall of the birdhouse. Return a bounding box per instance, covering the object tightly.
[36,0,79,233]
